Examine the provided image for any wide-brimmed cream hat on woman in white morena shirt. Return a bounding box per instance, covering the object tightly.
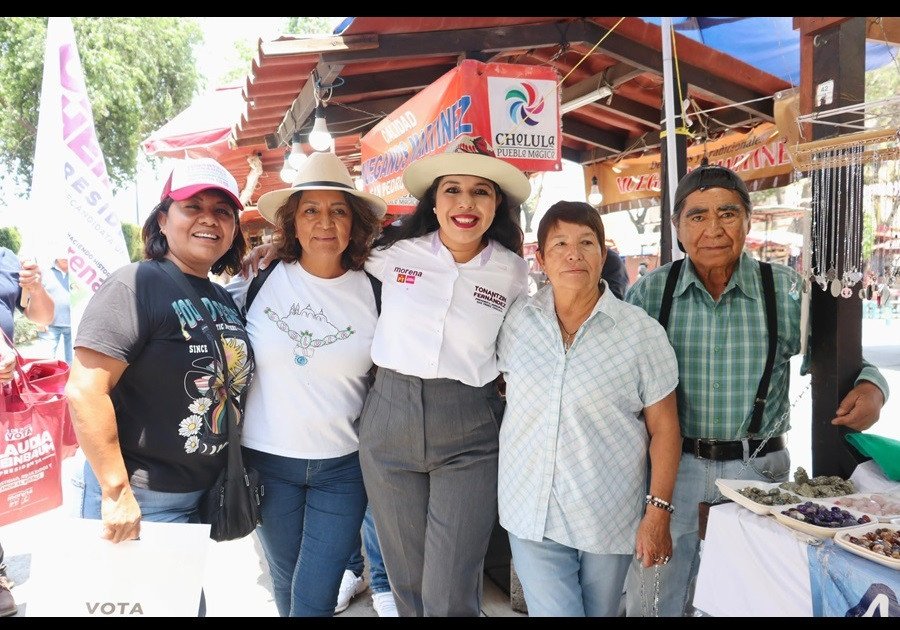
[403,136,531,206]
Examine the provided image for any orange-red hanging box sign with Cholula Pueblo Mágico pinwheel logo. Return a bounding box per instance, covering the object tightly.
[361,59,562,214]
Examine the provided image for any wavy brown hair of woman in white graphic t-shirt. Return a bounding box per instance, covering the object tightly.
[275,190,381,271]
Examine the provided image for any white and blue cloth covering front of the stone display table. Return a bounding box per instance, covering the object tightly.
[693,503,900,617]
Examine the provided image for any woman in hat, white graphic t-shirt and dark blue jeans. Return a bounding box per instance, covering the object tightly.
[228,153,386,617]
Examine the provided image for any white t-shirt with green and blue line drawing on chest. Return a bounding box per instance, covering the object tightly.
[226,262,378,459]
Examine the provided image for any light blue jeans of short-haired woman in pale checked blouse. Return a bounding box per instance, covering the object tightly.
[509,534,631,617]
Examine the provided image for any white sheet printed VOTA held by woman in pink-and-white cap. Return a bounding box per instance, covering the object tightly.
[27,518,211,617]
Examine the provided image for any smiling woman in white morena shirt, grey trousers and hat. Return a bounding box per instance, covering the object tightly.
[360,137,530,617]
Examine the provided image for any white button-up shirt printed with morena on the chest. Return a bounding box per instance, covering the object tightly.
[366,231,528,387]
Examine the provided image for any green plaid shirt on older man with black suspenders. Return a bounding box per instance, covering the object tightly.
[625,252,888,440]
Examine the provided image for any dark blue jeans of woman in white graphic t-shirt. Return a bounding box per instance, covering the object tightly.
[244,449,367,617]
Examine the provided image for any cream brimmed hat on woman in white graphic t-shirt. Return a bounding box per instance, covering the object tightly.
[256,151,387,225]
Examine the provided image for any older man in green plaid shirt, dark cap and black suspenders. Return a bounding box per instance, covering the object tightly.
[625,164,888,616]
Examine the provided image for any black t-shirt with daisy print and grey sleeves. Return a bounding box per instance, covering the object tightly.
[75,260,253,492]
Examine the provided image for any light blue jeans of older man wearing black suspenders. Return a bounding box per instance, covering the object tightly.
[625,448,791,617]
